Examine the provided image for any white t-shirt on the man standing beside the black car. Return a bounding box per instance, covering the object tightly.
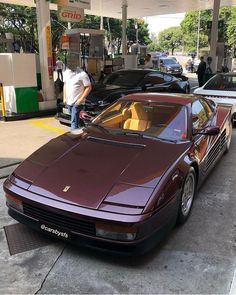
[64,69,91,105]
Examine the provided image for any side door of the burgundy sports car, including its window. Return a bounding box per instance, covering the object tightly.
[191,99,214,176]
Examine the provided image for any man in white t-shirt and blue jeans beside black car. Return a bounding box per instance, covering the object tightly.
[64,68,92,130]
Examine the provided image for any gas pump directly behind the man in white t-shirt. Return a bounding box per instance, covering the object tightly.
[65,28,105,80]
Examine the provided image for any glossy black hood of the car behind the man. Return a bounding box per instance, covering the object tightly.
[86,84,138,104]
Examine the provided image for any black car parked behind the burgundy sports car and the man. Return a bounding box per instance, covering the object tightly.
[58,69,190,124]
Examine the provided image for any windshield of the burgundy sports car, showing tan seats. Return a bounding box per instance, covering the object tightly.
[91,100,187,141]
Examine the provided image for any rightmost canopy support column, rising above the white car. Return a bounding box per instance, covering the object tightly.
[210,0,220,73]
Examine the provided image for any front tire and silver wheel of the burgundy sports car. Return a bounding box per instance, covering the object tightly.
[177,167,196,224]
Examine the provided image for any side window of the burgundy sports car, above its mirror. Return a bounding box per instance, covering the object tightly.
[192,100,208,129]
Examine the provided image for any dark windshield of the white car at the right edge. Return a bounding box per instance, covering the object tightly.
[204,74,236,91]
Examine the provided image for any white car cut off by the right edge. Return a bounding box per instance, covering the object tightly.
[194,72,236,125]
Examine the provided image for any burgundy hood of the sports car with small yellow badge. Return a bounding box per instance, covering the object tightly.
[15,134,190,209]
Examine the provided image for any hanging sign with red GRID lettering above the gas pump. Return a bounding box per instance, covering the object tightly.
[58,6,84,23]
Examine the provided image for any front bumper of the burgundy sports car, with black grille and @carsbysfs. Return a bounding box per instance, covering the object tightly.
[4,179,178,254]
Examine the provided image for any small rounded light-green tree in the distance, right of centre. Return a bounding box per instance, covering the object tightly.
[158,27,183,55]
